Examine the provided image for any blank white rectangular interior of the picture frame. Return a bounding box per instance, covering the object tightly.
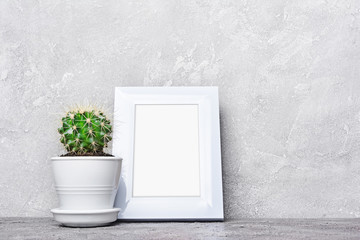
[132,104,200,197]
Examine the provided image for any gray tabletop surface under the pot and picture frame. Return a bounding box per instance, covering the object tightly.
[0,218,360,240]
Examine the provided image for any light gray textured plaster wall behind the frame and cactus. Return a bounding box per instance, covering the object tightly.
[0,0,360,219]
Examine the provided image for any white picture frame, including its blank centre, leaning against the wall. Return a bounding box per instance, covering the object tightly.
[112,87,224,221]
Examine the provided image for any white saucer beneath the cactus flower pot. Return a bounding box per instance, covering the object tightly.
[51,208,120,227]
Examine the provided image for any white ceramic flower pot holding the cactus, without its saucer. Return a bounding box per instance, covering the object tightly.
[51,156,121,210]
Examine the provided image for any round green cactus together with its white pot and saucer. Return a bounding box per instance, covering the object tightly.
[51,108,121,227]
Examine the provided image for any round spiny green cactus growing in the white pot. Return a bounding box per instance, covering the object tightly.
[58,109,112,156]
